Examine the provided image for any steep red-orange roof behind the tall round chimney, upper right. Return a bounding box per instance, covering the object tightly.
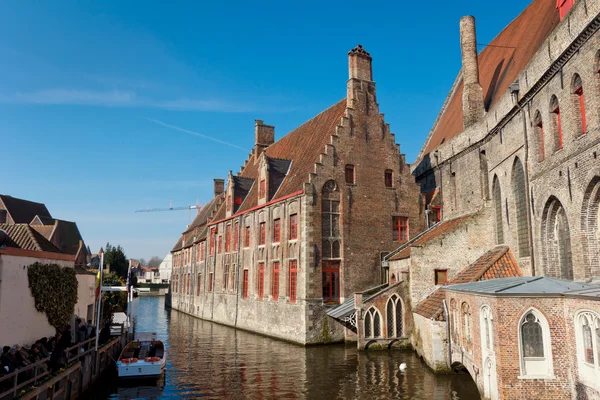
[419,0,560,159]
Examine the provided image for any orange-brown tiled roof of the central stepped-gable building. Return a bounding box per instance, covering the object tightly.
[224,98,346,216]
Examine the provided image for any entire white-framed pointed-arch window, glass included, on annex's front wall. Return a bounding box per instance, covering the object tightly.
[519,309,552,378]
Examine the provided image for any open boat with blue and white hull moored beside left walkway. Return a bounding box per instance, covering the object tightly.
[117,332,167,379]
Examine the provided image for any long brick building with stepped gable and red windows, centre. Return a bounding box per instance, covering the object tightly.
[172,45,424,344]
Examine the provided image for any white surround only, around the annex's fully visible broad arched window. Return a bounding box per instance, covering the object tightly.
[517,307,555,379]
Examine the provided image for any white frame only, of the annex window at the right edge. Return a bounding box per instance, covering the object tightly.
[573,310,600,390]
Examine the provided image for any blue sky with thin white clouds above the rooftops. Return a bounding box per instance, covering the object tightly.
[0,0,529,259]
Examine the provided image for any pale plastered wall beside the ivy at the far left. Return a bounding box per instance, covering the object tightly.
[0,254,74,346]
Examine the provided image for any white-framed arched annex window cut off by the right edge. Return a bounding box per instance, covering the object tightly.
[575,311,600,390]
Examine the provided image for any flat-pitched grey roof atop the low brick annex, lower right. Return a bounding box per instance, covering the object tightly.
[447,276,600,295]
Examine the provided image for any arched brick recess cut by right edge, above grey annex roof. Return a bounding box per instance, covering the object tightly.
[581,176,600,279]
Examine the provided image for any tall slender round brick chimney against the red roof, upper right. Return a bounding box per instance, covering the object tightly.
[460,15,485,129]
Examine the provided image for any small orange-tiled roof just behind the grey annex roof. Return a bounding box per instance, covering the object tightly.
[415,246,523,321]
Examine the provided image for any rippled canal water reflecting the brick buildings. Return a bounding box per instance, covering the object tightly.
[87,297,479,400]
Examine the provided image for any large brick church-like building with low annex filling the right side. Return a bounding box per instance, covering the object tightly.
[353,0,600,399]
